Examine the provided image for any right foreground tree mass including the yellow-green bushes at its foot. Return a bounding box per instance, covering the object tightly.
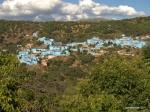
[58,55,150,112]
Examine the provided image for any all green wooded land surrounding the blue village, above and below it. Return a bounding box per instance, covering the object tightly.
[0,17,150,112]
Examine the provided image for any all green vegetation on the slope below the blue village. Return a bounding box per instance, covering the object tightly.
[0,50,150,112]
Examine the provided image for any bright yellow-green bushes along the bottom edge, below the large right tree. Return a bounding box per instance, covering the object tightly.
[59,94,122,112]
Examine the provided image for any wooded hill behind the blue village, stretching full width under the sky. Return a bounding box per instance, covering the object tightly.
[0,17,150,52]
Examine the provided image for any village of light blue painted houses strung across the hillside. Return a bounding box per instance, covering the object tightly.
[17,37,145,65]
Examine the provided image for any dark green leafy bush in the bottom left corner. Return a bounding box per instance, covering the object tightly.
[0,78,23,112]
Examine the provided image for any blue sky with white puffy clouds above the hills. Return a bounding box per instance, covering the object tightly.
[0,0,150,21]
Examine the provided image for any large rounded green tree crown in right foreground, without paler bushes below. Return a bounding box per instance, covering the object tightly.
[81,56,150,108]
